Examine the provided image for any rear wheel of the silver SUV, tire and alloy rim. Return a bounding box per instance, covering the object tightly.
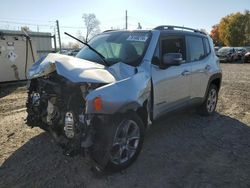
[197,84,218,116]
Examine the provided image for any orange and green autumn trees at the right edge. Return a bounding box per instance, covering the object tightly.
[210,10,250,46]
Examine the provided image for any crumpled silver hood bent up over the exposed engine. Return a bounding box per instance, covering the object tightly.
[28,53,135,83]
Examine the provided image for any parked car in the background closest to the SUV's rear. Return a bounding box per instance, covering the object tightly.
[217,47,238,63]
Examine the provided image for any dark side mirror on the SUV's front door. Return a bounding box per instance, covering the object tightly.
[162,53,183,67]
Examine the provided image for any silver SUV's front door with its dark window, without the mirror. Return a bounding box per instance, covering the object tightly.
[151,35,191,118]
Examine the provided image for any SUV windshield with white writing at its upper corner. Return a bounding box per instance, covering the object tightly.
[76,31,150,66]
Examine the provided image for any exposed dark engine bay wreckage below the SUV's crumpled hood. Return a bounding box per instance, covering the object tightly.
[26,72,103,152]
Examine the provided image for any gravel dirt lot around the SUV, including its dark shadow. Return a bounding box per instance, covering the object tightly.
[0,64,250,188]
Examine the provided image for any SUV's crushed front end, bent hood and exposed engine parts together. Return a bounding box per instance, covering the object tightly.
[26,54,115,154]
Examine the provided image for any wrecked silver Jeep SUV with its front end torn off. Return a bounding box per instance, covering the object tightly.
[27,26,222,171]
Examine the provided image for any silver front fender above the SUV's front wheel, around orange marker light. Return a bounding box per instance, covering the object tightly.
[85,71,151,114]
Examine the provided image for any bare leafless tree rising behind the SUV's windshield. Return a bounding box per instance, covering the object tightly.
[82,14,100,42]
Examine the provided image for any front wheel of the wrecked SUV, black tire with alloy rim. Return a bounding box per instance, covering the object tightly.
[91,112,145,172]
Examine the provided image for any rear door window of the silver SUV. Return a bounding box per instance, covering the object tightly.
[187,36,206,61]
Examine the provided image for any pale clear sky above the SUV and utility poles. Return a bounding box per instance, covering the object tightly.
[0,0,250,42]
